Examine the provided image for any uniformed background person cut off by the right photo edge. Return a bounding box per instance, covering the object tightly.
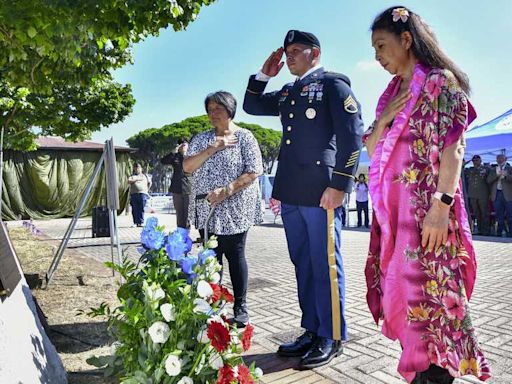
[487,155,512,237]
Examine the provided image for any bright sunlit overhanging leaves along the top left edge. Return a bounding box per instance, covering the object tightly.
[0,0,213,92]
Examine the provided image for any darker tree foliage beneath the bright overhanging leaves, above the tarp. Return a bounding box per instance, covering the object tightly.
[0,81,135,151]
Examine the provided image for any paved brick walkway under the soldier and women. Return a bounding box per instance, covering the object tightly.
[24,210,512,384]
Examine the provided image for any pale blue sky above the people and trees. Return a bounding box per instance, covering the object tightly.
[92,0,512,145]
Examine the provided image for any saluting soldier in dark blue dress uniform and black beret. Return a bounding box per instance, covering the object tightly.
[244,30,363,369]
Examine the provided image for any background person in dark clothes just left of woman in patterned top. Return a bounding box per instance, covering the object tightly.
[160,139,192,229]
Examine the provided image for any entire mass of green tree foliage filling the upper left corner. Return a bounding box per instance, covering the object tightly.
[0,0,214,149]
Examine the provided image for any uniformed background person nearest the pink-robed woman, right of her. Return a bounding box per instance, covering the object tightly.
[465,155,490,236]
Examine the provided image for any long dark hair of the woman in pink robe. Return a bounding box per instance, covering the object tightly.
[370,5,471,94]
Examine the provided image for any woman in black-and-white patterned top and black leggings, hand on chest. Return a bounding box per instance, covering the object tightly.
[183,91,263,327]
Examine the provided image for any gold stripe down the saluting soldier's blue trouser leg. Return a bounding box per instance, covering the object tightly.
[327,209,341,340]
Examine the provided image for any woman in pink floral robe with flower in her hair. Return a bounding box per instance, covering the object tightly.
[364,7,490,384]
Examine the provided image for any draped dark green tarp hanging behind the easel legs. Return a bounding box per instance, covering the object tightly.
[2,149,131,220]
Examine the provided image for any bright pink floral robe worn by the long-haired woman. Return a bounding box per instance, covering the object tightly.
[363,64,490,382]
